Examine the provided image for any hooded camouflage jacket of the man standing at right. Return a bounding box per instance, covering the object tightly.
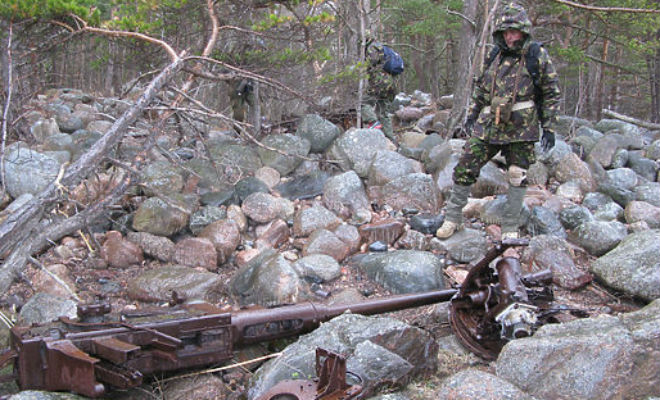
[468,5,561,144]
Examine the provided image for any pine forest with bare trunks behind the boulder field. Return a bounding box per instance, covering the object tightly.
[0,0,660,139]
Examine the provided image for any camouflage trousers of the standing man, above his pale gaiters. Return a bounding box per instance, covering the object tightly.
[453,137,536,186]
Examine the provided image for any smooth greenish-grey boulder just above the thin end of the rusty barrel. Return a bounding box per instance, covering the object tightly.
[357,250,444,293]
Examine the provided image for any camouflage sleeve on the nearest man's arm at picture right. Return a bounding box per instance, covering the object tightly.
[539,47,561,130]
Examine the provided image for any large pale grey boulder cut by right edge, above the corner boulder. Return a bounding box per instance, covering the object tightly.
[591,229,660,300]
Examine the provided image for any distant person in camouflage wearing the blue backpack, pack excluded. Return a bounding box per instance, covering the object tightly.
[362,40,396,139]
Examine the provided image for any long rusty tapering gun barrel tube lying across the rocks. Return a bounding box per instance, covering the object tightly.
[231,289,458,345]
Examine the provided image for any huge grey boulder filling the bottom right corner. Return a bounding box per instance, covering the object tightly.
[496,301,660,400]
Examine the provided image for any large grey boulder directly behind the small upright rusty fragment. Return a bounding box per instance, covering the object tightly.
[247,314,438,399]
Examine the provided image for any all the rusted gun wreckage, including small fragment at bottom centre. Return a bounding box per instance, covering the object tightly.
[0,240,552,400]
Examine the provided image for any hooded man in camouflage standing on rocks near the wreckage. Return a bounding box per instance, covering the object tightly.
[436,4,560,239]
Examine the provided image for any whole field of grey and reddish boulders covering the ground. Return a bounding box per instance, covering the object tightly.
[0,89,660,399]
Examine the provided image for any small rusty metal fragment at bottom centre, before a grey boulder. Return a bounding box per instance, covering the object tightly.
[255,348,362,400]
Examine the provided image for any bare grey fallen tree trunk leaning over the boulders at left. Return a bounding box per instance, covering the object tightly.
[0,57,184,293]
